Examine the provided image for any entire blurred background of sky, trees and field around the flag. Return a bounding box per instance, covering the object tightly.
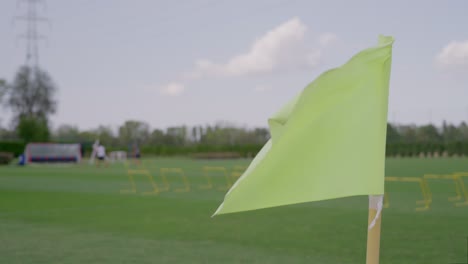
[0,0,468,264]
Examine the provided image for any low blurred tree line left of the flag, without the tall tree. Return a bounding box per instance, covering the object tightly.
[0,120,269,156]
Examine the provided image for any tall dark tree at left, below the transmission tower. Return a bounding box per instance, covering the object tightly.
[2,66,57,142]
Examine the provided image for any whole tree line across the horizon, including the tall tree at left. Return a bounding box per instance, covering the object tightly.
[0,66,468,156]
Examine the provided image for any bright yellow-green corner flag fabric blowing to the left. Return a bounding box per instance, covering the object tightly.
[215,36,393,215]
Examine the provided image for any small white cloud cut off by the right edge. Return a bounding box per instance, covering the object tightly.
[436,40,468,67]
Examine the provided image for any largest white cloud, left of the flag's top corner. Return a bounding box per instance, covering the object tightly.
[186,18,324,79]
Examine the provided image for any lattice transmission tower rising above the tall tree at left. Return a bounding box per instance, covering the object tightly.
[15,0,49,68]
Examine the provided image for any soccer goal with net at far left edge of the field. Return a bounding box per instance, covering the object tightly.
[24,143,81,163]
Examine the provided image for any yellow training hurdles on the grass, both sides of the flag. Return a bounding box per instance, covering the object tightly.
[120,163,468,211]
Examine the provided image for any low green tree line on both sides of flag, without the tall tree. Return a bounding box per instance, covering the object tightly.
[0,120,468,156]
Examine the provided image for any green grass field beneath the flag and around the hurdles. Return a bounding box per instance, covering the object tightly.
[0,158,468,264]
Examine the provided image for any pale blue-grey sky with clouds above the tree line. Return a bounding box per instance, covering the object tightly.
[0,0,468,129]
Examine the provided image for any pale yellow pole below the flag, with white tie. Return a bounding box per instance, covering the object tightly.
[366,195,383,264]
